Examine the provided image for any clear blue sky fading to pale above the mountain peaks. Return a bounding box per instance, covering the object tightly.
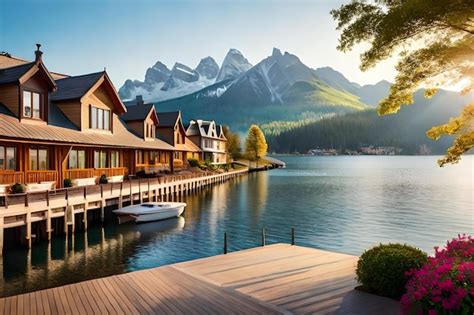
[0,0,394,88]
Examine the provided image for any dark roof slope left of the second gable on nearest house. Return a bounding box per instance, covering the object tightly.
[51,71,104,101]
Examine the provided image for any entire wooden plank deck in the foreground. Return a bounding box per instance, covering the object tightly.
[0,244,399,315]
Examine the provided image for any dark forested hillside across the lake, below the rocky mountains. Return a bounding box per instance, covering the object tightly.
[267,91,469,154]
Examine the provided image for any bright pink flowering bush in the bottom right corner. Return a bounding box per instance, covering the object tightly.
[401,235,474,315]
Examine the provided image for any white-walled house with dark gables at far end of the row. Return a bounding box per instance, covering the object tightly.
[186,119,227,164]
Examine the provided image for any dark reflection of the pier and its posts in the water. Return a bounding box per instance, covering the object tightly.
[0,217,185,294]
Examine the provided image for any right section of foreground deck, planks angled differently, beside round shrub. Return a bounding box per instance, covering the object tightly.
[173,244,399,314]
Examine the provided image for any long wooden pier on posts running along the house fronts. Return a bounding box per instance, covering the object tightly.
[0,169,244,255]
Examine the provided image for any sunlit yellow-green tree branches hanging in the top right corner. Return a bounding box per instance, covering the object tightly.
[331,0,474,166]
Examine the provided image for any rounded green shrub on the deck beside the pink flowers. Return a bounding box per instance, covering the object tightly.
[356,244,428,299]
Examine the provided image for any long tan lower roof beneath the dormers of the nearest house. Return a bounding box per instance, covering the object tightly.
[0,105,173,150]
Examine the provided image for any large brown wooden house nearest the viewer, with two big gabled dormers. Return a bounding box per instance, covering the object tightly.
[0,45,174,193]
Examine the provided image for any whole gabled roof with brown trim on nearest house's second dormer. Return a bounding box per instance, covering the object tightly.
[51,71,127,114]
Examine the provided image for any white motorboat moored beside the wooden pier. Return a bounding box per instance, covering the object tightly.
[112,202,186,223]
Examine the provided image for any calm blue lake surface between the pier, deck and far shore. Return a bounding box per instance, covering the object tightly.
[0,156,474,296]
